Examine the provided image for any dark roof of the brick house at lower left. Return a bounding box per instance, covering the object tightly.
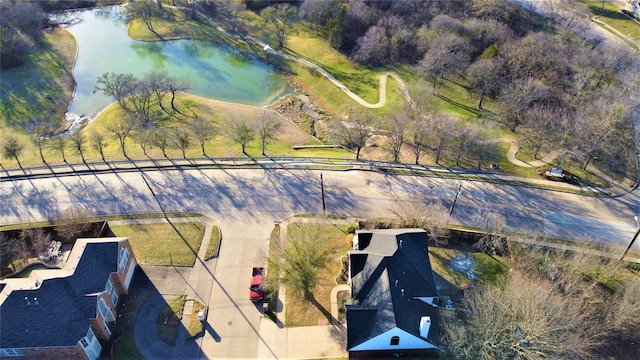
[0,242,118,348]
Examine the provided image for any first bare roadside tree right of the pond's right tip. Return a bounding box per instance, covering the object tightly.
[329,111,375,160]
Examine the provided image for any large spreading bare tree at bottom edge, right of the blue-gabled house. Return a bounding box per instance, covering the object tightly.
[443,270,605,360]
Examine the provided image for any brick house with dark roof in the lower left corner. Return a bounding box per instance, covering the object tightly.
[0,238,137,360]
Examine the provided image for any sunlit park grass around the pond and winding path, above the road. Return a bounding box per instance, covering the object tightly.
[0,0,637,183]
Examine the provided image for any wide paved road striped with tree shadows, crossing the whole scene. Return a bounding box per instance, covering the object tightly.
[0,169,640,250]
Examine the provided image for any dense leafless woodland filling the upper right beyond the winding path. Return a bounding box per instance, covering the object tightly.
[299,0,640,174]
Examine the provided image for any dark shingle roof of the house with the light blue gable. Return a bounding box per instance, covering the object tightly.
[347,229,438,349]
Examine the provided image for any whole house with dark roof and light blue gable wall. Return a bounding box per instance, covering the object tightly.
[345,229,440,359]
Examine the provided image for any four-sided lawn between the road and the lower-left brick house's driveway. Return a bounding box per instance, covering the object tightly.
[111,222,205,266]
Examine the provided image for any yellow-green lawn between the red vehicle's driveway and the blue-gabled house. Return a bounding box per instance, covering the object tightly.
[285,223,353,327]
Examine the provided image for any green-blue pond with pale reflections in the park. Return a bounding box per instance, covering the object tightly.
[61,6,292,118]
